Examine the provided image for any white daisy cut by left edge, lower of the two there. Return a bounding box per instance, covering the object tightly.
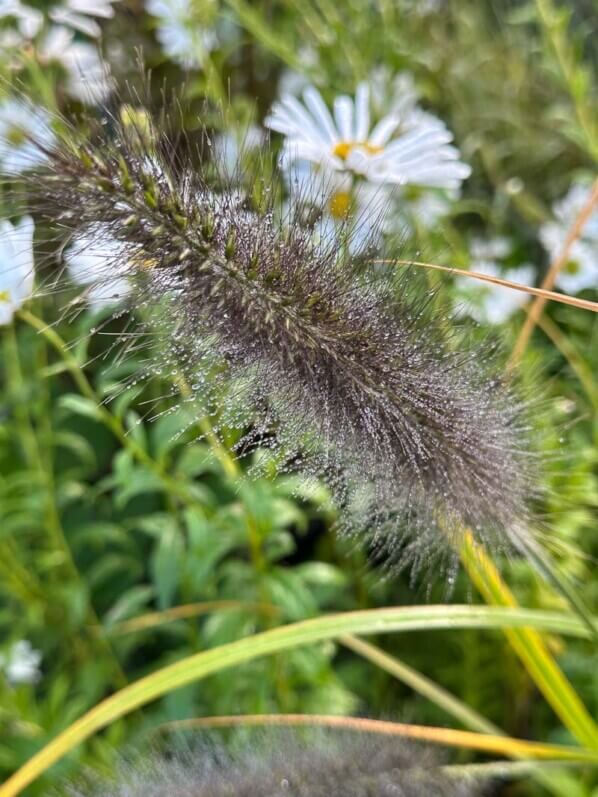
[0,216,34,325]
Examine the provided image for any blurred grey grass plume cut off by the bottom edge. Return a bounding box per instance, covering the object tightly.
[72,734,481,797]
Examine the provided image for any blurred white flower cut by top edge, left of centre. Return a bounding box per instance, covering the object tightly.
[145,0,218,69]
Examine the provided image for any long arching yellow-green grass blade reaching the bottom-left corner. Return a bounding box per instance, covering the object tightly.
[0,605,588,797]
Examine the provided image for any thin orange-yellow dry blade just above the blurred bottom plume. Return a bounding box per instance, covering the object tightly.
[161,714,598,762]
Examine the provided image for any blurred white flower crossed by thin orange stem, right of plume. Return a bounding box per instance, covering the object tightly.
[457,236,536,324]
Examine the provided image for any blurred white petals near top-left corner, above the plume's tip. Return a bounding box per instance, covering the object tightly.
[38,25,110,105]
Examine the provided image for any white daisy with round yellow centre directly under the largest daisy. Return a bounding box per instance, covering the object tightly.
[286,161,393,254]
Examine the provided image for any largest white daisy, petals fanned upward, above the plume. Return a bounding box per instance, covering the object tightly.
[265,77,471,188]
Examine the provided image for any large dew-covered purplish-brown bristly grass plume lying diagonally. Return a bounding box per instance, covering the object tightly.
[16,101,535,570]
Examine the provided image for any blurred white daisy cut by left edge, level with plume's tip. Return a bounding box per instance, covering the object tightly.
[0,98,55,174]
